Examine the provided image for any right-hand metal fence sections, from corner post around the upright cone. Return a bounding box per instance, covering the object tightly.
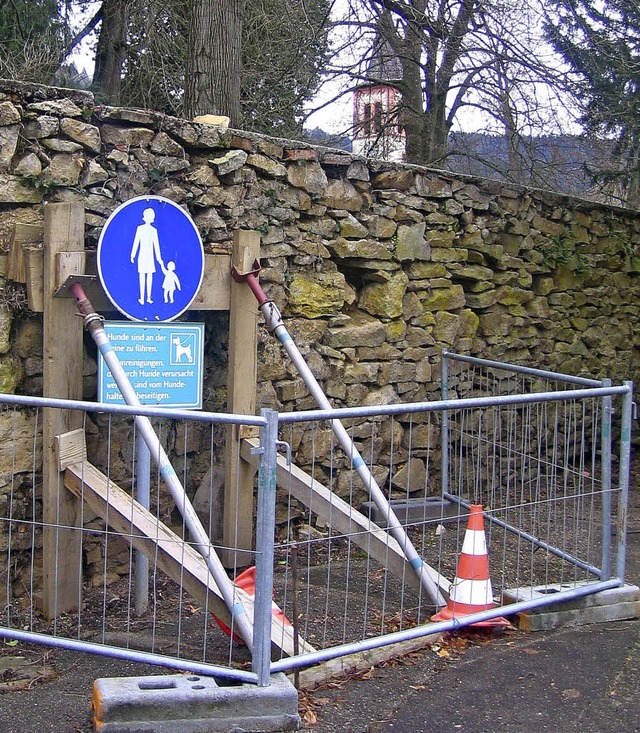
[272,354,632,671]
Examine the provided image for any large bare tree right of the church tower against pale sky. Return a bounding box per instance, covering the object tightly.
[322,0,576,167]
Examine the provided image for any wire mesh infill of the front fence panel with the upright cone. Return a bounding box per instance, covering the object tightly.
[268,374,609,664]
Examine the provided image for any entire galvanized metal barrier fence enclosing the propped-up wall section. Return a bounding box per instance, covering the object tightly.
[0,354,632,685]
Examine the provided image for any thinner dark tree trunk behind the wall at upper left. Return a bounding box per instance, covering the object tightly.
[93,0,131,105]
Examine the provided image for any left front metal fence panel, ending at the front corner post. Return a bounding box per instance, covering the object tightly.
[0,395,275,682]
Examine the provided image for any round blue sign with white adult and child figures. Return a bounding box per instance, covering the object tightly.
[98,196,204,322]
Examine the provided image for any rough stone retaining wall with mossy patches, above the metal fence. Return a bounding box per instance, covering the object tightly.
[0,82,640,576]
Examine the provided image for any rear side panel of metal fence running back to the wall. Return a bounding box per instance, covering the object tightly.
[441,351,633,578]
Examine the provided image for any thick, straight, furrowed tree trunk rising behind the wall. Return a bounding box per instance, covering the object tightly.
[184,0,244,127]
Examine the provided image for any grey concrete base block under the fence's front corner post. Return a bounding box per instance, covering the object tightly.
[93,674,300,733]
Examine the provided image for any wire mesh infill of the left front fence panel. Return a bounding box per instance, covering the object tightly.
[0,405,258,669]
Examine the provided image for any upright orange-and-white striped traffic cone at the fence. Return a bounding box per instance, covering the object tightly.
[431,504,511,627]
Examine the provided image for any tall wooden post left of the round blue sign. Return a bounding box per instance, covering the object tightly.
[42,203,85,619]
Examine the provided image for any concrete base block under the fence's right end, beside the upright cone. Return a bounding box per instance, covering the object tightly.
[502,581,640,631]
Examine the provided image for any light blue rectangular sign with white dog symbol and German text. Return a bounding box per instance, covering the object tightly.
[98,321,204,409]
